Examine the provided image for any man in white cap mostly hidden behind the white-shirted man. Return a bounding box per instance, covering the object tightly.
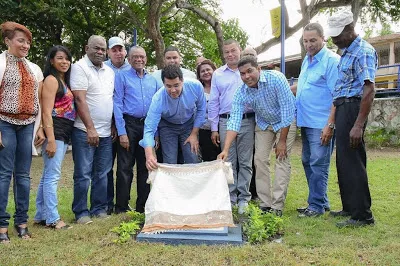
[104,36,131,214]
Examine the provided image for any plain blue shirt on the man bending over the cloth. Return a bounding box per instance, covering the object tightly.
[139,79,206,148]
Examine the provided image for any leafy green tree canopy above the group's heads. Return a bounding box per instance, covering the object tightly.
[0,0,400,69]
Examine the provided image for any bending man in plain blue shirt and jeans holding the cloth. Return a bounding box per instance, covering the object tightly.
[139,65,206,171]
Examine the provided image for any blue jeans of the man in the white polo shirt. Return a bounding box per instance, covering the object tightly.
[72,128,112,220]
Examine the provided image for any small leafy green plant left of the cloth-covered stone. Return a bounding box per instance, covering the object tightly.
[111,211,145,244]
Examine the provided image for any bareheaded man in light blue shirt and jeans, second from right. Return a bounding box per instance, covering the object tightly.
[291,23,340,217]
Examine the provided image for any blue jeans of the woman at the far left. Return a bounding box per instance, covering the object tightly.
[0,120,33,228]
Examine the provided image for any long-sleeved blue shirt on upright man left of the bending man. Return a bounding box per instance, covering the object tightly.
[114,67,158,136]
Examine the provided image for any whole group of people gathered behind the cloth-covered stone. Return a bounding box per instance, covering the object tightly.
[0,8,377,243]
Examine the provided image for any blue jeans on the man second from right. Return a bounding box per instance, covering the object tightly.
[301,127,332,213]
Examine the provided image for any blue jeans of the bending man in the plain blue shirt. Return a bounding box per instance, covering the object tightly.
[158,118,200,164]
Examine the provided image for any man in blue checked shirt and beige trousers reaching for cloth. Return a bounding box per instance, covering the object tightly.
[218,56,295,216]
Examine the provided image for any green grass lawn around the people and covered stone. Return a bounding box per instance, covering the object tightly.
[0,143,400,265]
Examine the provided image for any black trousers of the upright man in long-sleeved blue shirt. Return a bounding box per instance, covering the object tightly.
[115,115,150,213]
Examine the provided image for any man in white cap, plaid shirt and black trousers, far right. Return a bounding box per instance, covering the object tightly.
[326,10,378,228]
